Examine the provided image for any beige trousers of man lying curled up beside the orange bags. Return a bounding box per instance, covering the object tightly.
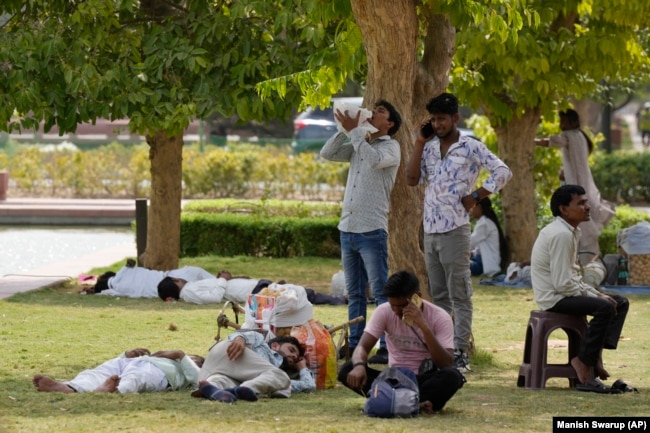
[199,341,291,397]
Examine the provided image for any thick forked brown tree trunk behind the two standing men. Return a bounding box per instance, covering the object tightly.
[351,0,454,292]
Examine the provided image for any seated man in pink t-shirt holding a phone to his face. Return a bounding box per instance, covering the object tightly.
[338,271,465,413]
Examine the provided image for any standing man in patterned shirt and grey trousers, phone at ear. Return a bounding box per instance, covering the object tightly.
[406,93,512,372]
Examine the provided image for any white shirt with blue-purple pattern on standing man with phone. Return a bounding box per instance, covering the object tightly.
[420,135,512,233]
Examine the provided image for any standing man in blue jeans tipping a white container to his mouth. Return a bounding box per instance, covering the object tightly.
[320,100,402,364]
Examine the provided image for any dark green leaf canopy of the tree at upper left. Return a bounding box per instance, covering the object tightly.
[0,0,346,135]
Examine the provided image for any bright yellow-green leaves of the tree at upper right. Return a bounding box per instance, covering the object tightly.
[451,0,649,126]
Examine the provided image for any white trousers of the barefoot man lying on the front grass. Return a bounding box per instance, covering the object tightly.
[64,358,169,394]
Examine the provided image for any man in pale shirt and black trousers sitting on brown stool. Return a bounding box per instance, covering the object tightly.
[531,185,629,392]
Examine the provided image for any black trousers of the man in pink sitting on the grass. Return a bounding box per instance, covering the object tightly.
[338,361,465,411]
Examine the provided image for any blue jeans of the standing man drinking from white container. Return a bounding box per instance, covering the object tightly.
[341,229,388,347]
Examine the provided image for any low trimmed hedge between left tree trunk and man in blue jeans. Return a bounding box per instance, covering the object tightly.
[181,212,340,257]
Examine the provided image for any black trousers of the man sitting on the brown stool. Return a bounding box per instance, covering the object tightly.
[549,294,630,367]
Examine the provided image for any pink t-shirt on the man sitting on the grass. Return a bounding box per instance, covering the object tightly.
[365,300,454,373]
